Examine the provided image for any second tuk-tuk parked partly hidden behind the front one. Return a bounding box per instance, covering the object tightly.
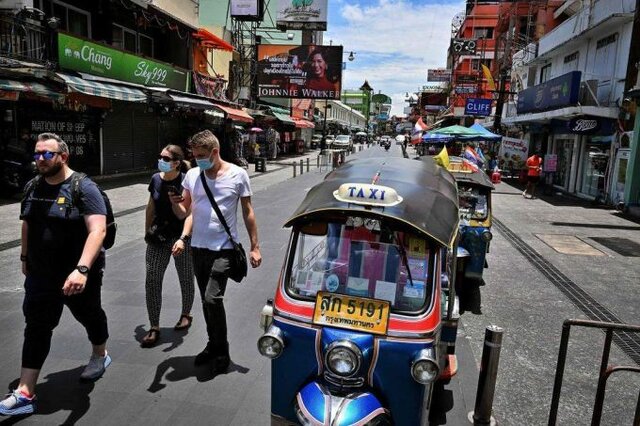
[447,157,495,314]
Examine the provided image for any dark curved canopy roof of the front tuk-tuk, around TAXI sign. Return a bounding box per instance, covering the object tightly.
[284,157,459,246]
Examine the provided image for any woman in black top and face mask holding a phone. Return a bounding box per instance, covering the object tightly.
[141,145,195,348]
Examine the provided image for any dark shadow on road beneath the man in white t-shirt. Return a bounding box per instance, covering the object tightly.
[147,356,249,393]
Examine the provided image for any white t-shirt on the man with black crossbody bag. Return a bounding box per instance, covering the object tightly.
[182,164,252,251]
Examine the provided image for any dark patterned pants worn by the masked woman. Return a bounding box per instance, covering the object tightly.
[145,238,194,327]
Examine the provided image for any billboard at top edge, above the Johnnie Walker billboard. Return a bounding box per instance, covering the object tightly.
[276,0,328,31]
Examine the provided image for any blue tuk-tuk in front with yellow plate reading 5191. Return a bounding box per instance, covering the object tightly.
[258,158,458,426]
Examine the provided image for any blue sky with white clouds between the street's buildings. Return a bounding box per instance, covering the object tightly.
[324,0,465,115]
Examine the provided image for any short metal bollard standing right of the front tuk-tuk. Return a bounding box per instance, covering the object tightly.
[473,325,504,425]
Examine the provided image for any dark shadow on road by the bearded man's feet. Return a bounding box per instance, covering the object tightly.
[0,366,95,426]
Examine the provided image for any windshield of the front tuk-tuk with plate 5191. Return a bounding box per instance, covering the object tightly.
[287,217,434,312]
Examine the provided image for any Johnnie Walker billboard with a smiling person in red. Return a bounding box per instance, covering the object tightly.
[257,44,342,99]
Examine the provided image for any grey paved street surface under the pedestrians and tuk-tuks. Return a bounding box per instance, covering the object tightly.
[0,144,640,425]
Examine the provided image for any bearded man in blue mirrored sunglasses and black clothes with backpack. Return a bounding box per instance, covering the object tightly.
[0,133,111,415]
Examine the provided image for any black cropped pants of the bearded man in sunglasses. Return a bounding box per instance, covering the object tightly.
[22,270,109,370]
